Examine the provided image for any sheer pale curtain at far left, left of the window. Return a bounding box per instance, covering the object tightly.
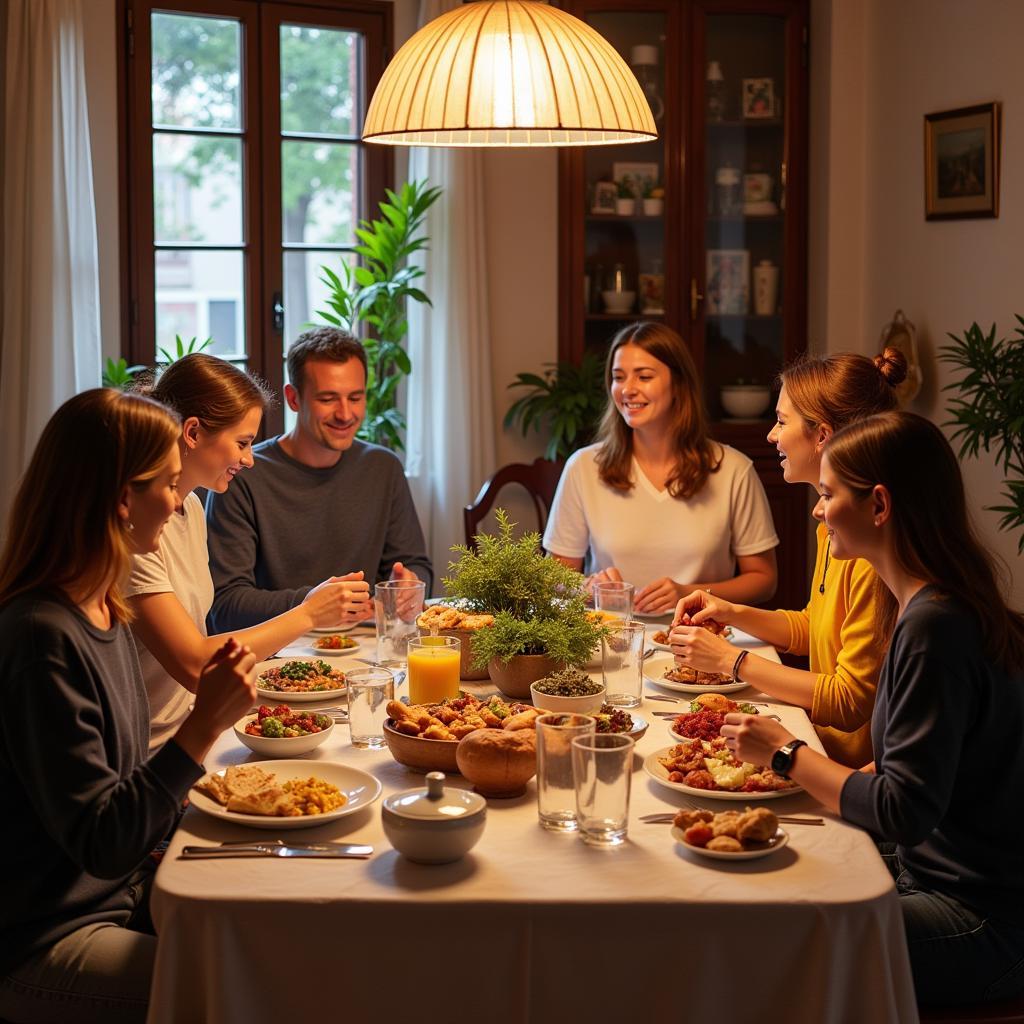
[0,0,101,536]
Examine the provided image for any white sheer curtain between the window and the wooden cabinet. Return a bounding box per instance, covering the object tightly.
[406,0,495,593]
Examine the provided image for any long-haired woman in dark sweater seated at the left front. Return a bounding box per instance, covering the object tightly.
[0,389,255,1024]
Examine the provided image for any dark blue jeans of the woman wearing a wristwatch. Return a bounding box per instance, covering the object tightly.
[879,843,1024,1006]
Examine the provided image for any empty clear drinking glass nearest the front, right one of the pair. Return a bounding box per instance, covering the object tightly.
[572,732,633,847]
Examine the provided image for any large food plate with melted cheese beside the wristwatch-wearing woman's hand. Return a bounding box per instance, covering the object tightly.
[643,736,804,801]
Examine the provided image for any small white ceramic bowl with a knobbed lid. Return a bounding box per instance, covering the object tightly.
[381,774,487,864]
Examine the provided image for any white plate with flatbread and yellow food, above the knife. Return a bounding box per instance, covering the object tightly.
[188,761,381,829]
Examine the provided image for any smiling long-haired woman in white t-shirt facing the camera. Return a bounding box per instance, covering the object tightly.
[544,323,778,614]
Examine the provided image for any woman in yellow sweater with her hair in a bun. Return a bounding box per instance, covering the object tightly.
[671,348,906,768]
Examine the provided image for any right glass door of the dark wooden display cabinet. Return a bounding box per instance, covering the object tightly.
[689,13,787,422]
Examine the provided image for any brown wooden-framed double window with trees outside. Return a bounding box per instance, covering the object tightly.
[122,0,391,430]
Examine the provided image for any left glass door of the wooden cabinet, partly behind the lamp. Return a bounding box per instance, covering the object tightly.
[581,9,667,352]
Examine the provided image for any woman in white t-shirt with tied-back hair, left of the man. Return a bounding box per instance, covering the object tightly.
[125,353,371,749]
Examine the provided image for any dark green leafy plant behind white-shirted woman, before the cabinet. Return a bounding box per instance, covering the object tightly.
[505,352,607,461]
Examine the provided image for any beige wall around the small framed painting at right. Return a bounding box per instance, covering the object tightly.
[810,0,1024,607]
